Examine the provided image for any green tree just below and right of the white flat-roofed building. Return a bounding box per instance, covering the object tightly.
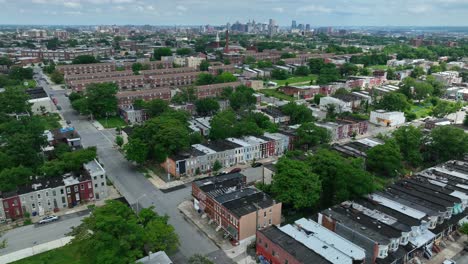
[393,126,423,167]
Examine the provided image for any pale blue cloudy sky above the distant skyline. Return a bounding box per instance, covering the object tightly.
[0,0,468,27]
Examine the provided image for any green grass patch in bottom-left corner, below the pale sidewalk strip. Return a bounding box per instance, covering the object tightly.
[13,242,85,264]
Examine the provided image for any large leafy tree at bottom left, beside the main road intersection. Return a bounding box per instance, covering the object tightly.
[71,200,179,264]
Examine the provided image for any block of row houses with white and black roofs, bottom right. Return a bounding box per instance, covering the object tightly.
[256,161,468,264]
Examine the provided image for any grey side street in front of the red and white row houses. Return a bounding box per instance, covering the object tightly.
[0,212,88,255]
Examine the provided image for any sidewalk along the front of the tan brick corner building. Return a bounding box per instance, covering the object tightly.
[177,201,256,264]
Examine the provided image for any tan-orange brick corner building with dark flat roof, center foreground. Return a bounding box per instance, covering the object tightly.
[192,173,282,244]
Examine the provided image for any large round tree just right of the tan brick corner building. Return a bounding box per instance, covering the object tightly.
[271,157,321,209]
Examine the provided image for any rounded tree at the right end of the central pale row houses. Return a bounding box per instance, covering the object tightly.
[295,122,331,150]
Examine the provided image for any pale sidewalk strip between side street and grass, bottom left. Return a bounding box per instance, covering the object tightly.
[0,236,73,263]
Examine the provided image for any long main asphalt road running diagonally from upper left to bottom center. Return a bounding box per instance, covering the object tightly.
[31,69,230,263]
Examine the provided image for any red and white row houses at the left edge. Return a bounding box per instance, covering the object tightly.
[0,160,108,220]
